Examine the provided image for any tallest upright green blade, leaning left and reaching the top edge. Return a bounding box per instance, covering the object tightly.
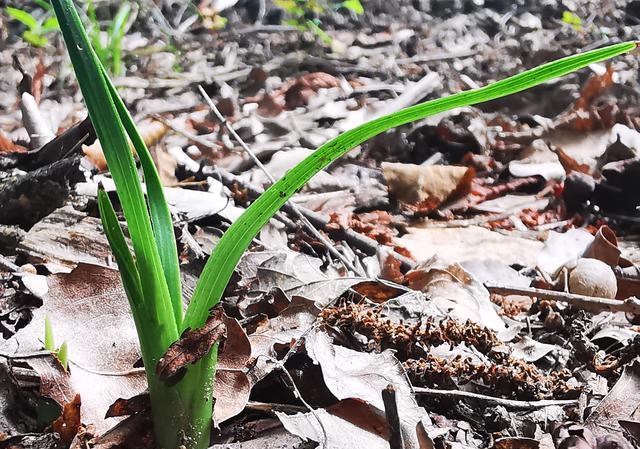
[52,0,178,344]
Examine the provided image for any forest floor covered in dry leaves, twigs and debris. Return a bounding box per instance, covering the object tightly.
[0,0,640,449]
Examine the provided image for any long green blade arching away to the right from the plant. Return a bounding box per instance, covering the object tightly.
[183,42,636,328]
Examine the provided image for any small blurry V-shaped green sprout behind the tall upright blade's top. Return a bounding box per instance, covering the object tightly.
[87,0,131,76]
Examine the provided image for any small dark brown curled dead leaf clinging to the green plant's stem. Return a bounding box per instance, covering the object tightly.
[156,306,226,385]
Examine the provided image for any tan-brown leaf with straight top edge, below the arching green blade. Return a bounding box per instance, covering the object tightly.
[382,162,475,206]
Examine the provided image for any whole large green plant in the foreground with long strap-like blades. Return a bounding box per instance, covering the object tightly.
[52,0,636,442]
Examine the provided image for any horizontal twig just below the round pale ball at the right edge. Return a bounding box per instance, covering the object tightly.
[485,284,640,315]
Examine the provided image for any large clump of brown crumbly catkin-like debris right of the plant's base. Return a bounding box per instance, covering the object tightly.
[320,303,576,399]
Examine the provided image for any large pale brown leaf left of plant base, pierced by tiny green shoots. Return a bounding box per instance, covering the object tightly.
[0,264,147,432]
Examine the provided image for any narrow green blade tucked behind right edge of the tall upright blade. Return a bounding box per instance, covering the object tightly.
[102,72,183,328]
